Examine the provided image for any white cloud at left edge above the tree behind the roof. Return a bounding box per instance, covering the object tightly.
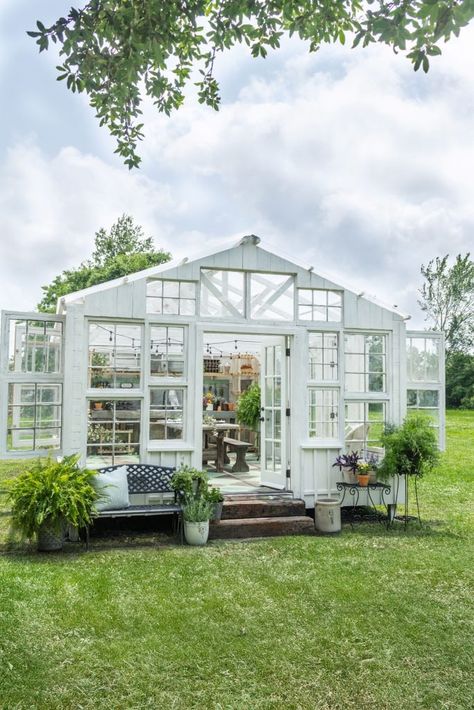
[0,141,179,308]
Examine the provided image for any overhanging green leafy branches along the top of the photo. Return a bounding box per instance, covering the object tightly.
[28,0,474,168]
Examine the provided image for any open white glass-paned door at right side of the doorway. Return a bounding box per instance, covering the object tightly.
[260,337,288,489]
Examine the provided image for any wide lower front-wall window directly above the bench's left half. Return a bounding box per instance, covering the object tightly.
[87,398,141,465]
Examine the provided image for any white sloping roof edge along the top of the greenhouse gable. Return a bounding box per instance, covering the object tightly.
[57,234,409,319]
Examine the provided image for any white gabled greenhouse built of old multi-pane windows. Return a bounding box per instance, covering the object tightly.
[0,235,444,508]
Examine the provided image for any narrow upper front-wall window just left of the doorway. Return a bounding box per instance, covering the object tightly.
[150,326,185,377]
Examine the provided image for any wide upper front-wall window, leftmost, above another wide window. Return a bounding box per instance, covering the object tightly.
[89,322,142,389]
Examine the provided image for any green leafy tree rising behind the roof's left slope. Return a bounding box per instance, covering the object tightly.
[38,215,171,313]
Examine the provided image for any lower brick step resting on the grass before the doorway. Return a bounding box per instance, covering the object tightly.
[209,515,314,540]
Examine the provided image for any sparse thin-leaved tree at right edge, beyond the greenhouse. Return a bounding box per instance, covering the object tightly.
[418,253,474,354]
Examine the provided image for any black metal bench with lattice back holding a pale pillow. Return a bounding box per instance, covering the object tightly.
[86,463,183,549]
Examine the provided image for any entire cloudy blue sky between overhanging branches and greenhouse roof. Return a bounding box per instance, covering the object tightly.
[0,0,474,327]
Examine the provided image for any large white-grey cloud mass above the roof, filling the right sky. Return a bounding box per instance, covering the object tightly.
[140,28,474,322]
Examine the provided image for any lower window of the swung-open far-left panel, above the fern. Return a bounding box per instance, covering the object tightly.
[7,382,62,451]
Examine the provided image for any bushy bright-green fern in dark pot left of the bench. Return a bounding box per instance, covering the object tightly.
[9,455,98,551]
